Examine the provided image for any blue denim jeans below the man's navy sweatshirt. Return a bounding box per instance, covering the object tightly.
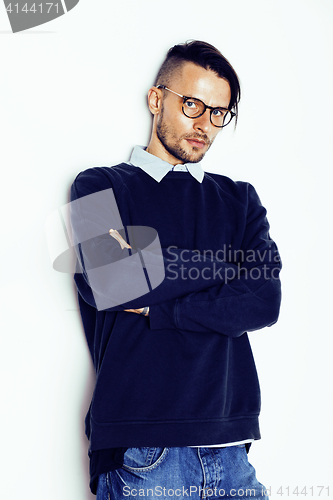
[97,445,268,500]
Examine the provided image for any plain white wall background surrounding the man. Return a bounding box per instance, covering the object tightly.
[0,0,333,500]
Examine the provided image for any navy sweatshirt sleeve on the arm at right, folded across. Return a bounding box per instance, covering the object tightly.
[149,184,281,337]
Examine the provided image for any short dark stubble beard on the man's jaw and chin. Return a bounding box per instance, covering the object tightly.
[156,109,213,163]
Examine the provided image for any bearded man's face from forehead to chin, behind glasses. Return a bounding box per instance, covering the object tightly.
[152,63,231,164]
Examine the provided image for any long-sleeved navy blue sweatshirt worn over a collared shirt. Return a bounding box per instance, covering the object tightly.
[71,164,281,492]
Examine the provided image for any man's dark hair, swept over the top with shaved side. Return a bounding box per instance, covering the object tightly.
[154,40,241,120]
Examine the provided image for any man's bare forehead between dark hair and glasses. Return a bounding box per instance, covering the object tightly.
[170,62,231,107]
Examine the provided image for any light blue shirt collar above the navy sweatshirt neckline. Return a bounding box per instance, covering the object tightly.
[130,146,205,182]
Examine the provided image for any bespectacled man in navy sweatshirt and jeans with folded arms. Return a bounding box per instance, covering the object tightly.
[72,41,280,500]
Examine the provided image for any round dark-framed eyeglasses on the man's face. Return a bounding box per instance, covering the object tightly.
[157,85,236,128]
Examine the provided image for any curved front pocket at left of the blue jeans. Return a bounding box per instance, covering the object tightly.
[123,448,169,472]
